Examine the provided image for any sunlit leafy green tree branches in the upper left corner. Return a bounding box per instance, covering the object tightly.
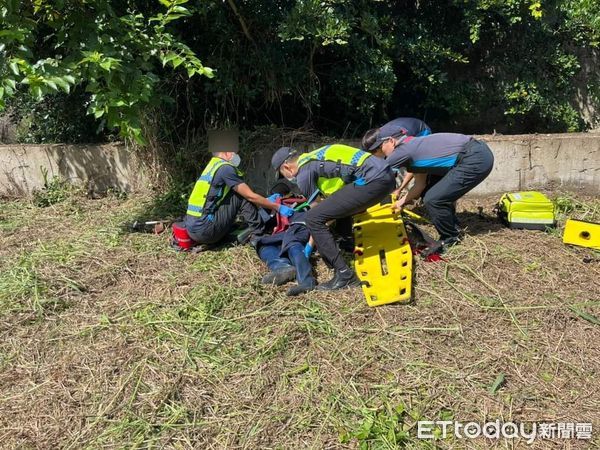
[0,0,213,143]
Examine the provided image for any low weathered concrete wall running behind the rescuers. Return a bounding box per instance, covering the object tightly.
[0,133,600,197]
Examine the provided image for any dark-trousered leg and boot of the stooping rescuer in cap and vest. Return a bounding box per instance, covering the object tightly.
[306,174,395,289]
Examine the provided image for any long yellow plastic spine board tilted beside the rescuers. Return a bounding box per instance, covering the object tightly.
[354,204,413,306]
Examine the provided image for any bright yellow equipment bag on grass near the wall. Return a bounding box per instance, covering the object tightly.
[496,191,556,230]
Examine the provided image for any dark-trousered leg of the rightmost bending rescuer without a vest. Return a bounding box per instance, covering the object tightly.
[423,141,494,240]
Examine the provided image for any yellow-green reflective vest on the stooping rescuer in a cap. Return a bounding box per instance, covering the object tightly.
[298,144,372,196]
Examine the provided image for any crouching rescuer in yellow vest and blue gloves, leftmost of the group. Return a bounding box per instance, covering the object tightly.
[185,152,294,244]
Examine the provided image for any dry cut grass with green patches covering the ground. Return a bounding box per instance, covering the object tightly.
[0,194,600,449]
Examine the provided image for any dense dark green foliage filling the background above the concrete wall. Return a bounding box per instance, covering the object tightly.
[0,0,600,142]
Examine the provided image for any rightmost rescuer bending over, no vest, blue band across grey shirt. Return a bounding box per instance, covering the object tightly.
[363,133,494,252]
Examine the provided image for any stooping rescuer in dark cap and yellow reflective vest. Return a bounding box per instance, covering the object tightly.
[271,144,395,290]
